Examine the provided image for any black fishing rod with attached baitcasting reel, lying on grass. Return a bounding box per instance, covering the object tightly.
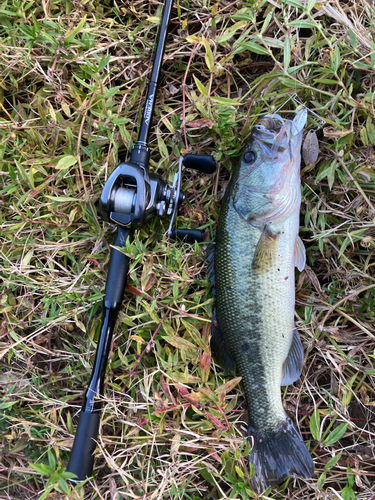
[67,0,216,482]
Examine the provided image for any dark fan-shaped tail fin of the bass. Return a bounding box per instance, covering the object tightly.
[249,417,314,493]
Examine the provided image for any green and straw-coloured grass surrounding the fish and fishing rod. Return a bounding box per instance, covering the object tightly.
[0,0,375,500]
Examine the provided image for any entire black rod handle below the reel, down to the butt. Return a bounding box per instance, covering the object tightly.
[67,226,133,483]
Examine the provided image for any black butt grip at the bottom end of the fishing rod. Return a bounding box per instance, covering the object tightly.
[67,411,100,483]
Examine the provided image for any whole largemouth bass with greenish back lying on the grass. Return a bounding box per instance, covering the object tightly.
[206,109,314,493]
